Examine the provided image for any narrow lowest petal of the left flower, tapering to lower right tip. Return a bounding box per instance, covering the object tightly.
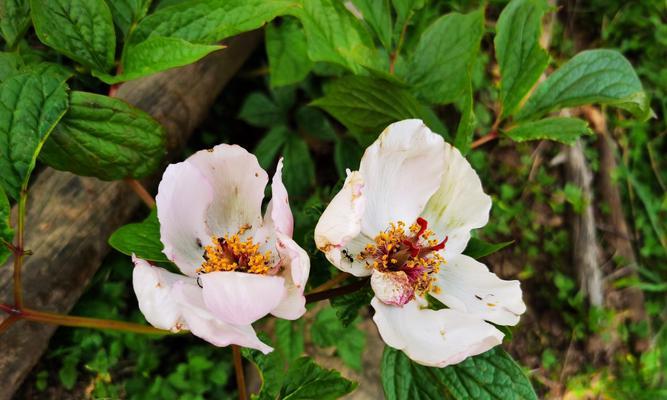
[173,283,273,354]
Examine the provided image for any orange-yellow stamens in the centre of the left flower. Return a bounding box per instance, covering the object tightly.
[197,228,273,274]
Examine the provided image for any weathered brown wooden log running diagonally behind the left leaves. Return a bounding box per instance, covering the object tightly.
[0,31,261,399]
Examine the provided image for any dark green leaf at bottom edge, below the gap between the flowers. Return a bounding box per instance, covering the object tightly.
[280,357,357,400]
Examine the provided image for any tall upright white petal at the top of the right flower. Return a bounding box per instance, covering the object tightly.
[359,119,445,237]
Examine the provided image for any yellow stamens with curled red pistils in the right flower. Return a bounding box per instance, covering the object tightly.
[357,218,448,300]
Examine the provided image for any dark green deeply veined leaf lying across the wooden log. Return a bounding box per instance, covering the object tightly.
[40,92,166,180]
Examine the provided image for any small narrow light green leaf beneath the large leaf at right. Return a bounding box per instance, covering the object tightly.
[504,117,593,144]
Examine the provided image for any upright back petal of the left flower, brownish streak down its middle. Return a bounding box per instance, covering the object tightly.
[186,144,269,237]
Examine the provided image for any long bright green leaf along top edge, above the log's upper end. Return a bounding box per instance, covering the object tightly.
[129,0,299,44]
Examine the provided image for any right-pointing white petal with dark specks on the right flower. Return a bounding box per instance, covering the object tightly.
[433,255,526,325]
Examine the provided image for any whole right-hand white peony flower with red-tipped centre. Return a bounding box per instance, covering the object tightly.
[315,120,526,367]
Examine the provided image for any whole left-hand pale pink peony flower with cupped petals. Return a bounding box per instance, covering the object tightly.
[133,144,310,353]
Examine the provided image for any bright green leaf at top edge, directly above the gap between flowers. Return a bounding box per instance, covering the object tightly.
[295,0,387,74]
